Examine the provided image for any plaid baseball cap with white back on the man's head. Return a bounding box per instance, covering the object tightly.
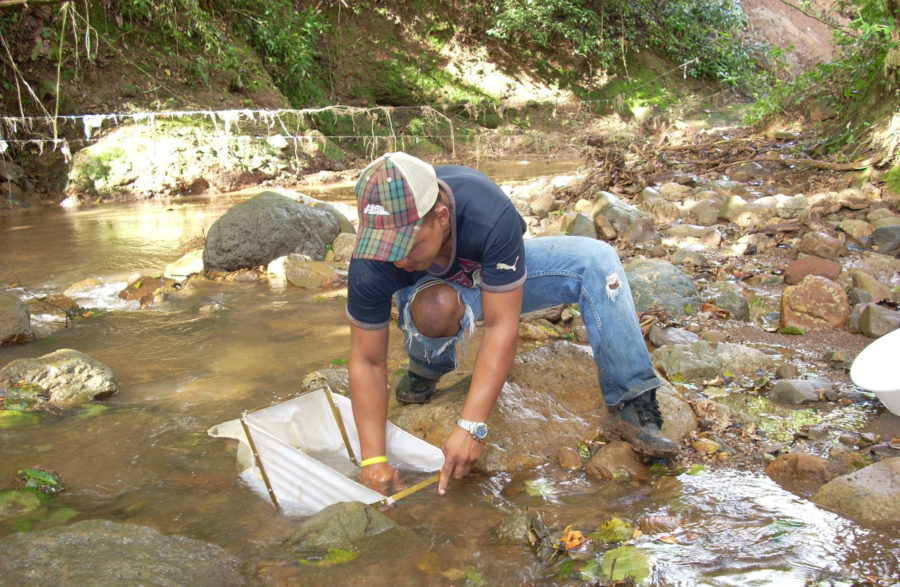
[353,152,438,262]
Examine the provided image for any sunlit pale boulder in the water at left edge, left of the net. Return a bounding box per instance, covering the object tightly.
[0,349,119,408]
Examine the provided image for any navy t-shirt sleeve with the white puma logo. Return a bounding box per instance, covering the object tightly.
[481,206,526,292]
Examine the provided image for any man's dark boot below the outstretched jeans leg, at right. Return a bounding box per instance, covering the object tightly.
[607,389,678,458]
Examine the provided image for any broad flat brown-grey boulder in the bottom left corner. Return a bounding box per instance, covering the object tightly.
[0,520,245,587]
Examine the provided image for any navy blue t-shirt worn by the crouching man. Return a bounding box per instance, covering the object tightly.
[347,165,526,330]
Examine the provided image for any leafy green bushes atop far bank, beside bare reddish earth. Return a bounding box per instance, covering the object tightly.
[472,0,767,93]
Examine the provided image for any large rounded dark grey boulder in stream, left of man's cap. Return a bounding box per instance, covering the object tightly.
[203,192,341,271]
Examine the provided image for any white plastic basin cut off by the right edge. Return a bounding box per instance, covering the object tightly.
[850,329,900,416]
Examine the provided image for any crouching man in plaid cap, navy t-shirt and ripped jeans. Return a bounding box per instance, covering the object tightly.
[347,153,677,494]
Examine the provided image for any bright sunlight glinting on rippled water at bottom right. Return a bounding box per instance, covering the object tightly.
[648,471,884,585]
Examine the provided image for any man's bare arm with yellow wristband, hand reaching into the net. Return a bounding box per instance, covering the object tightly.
[348,323,400,493]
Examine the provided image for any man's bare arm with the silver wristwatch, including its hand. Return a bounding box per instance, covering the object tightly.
[438,286,522,494]
